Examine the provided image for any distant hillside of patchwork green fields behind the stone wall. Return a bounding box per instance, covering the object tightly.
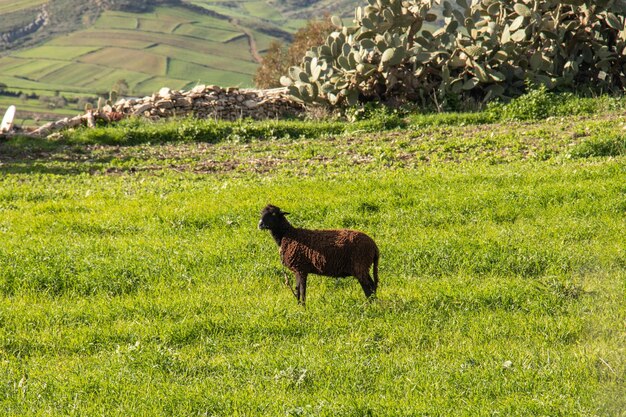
[0,0,322,121]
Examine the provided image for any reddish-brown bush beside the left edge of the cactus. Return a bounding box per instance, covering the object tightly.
[254,16,335,88]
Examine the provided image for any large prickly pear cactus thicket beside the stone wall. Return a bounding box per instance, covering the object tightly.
[281,0,626,109]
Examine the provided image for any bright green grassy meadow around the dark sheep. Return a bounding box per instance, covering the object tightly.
[0,97,626,416]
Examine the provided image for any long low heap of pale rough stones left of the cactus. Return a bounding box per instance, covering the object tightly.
[25,85,304,136]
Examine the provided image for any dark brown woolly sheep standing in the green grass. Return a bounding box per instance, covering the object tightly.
[259,205,379,304]
